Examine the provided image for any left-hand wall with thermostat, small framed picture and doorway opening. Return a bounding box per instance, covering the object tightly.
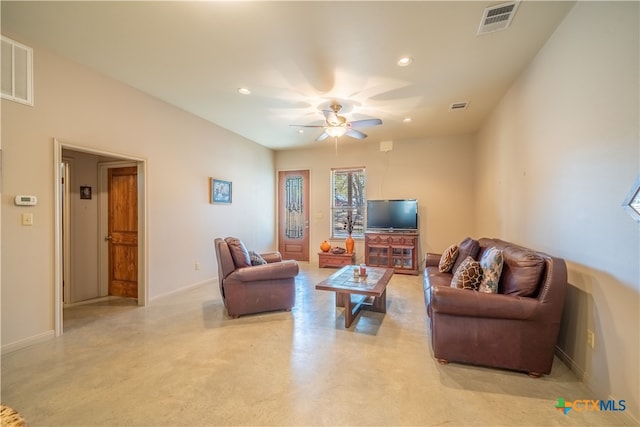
[1,40,275,351]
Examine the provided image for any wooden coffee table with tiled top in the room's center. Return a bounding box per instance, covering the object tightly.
[316,265,393,328]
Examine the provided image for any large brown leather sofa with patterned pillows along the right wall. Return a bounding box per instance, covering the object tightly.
[424,238,567,377]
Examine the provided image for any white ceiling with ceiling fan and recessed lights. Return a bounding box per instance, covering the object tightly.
[1,0,573,149]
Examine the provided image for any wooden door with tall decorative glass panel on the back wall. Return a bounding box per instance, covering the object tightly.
[278,170,309,261]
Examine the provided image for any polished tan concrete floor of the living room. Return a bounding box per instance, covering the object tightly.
[2,263,633,426]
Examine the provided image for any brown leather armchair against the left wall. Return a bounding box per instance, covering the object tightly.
[214,237,298,318]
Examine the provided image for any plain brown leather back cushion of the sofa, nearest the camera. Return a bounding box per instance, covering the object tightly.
[499,246,544,297]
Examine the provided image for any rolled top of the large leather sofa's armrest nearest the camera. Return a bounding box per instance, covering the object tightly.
[431,286,541,320]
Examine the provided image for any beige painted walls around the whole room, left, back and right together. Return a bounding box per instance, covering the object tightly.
[1,2,640,419]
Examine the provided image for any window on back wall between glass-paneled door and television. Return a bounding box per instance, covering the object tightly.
[331,168,367,238]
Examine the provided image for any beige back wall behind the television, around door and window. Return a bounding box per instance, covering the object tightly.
[276,136,475,267]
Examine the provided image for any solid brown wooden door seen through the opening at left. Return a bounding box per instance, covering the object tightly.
[107,166,138,298]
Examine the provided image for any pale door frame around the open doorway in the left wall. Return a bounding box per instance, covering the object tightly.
[53,138,149,336]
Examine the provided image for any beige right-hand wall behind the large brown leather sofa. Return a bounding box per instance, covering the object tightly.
[477,2,640,420]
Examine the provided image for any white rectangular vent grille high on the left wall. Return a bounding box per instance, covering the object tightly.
[0,36,33,105]
